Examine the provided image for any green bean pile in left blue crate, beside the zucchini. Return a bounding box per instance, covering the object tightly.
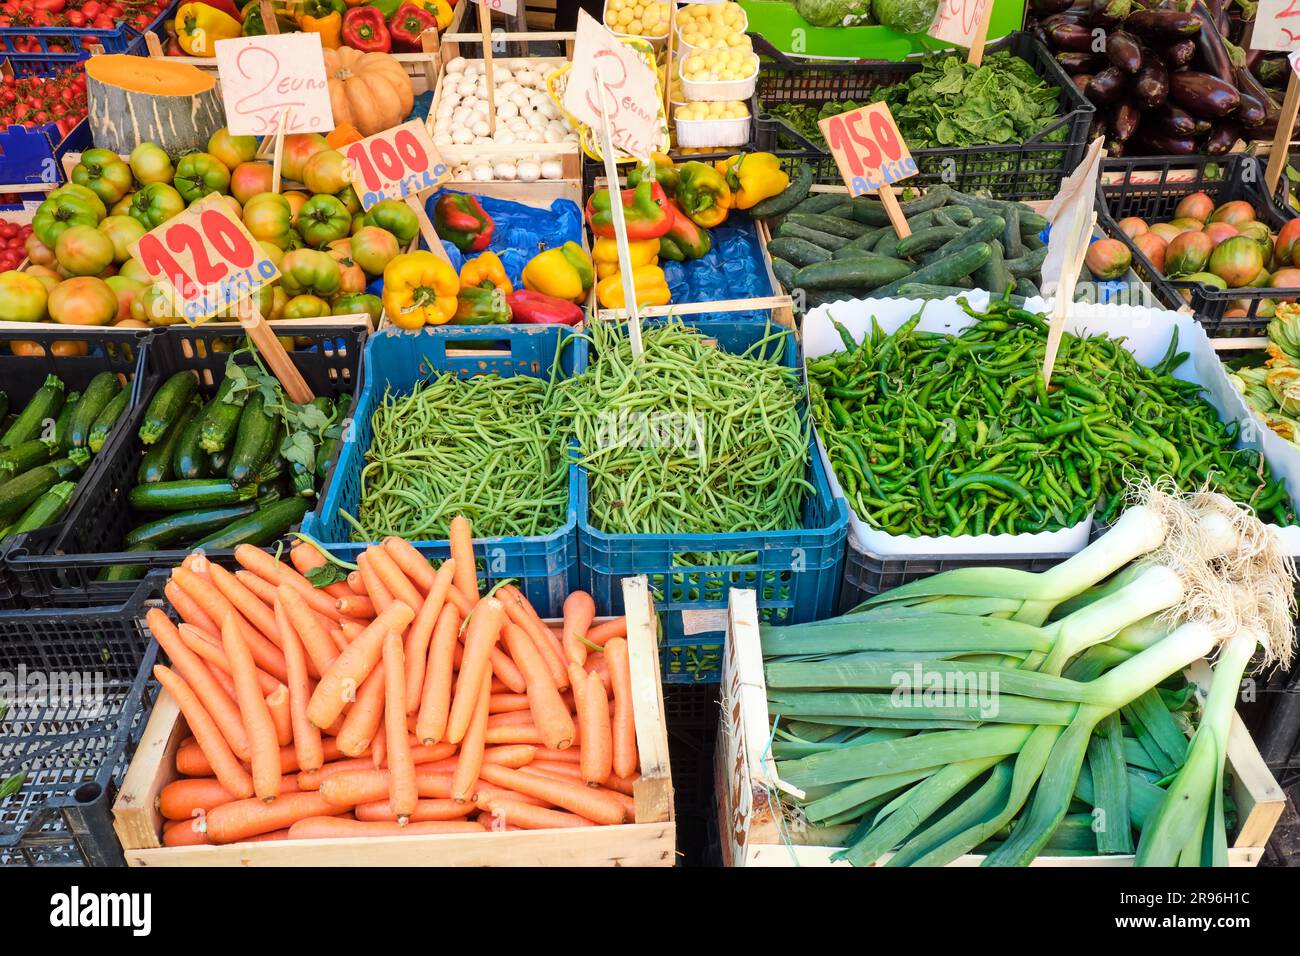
[345,373,568,541]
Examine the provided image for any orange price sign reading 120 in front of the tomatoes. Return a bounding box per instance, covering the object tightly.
[131,194,280,325]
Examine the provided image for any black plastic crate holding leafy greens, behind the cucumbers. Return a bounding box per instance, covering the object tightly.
[754,33,1095,200]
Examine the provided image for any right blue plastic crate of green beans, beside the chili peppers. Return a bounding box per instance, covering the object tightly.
[579,316,849,683]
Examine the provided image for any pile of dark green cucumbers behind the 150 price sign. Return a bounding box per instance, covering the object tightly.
[767,183,1055,308]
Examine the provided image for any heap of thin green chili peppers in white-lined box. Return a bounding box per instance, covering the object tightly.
[809,300,1296,536]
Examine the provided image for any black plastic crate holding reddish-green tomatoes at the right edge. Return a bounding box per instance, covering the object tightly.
[1097,153,1300,338]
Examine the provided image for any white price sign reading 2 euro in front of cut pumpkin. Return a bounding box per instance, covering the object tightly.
[217,33,334,137]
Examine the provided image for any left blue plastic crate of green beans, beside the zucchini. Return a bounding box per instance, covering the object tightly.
[303,325,586,617]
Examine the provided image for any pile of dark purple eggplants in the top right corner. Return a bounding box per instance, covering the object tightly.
[1031,0,1278,156]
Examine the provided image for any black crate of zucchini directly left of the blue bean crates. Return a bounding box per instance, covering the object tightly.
[7,323,367,606]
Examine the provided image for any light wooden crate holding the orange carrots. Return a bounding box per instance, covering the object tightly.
[113,578,676,866]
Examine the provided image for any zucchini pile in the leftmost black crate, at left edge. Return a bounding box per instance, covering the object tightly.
[0,372,131,538]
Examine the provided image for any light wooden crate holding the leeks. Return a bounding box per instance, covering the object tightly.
[714,589,1286,866]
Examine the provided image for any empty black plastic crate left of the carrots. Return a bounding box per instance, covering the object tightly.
[0,579,160,866]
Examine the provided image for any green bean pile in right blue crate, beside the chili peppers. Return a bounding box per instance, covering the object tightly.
[558,320,811,535]
